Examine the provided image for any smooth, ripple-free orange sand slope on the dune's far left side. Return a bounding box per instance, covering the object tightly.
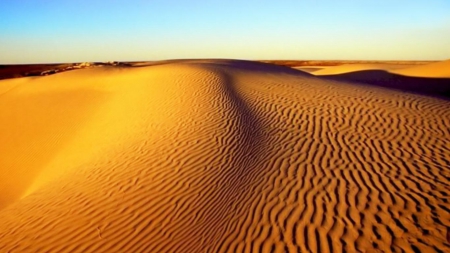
[0,76,105,208]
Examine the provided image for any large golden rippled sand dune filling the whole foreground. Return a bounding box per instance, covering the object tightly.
[0,60,450,252]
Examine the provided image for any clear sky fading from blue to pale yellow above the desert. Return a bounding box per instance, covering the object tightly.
[0,0,450,64]
